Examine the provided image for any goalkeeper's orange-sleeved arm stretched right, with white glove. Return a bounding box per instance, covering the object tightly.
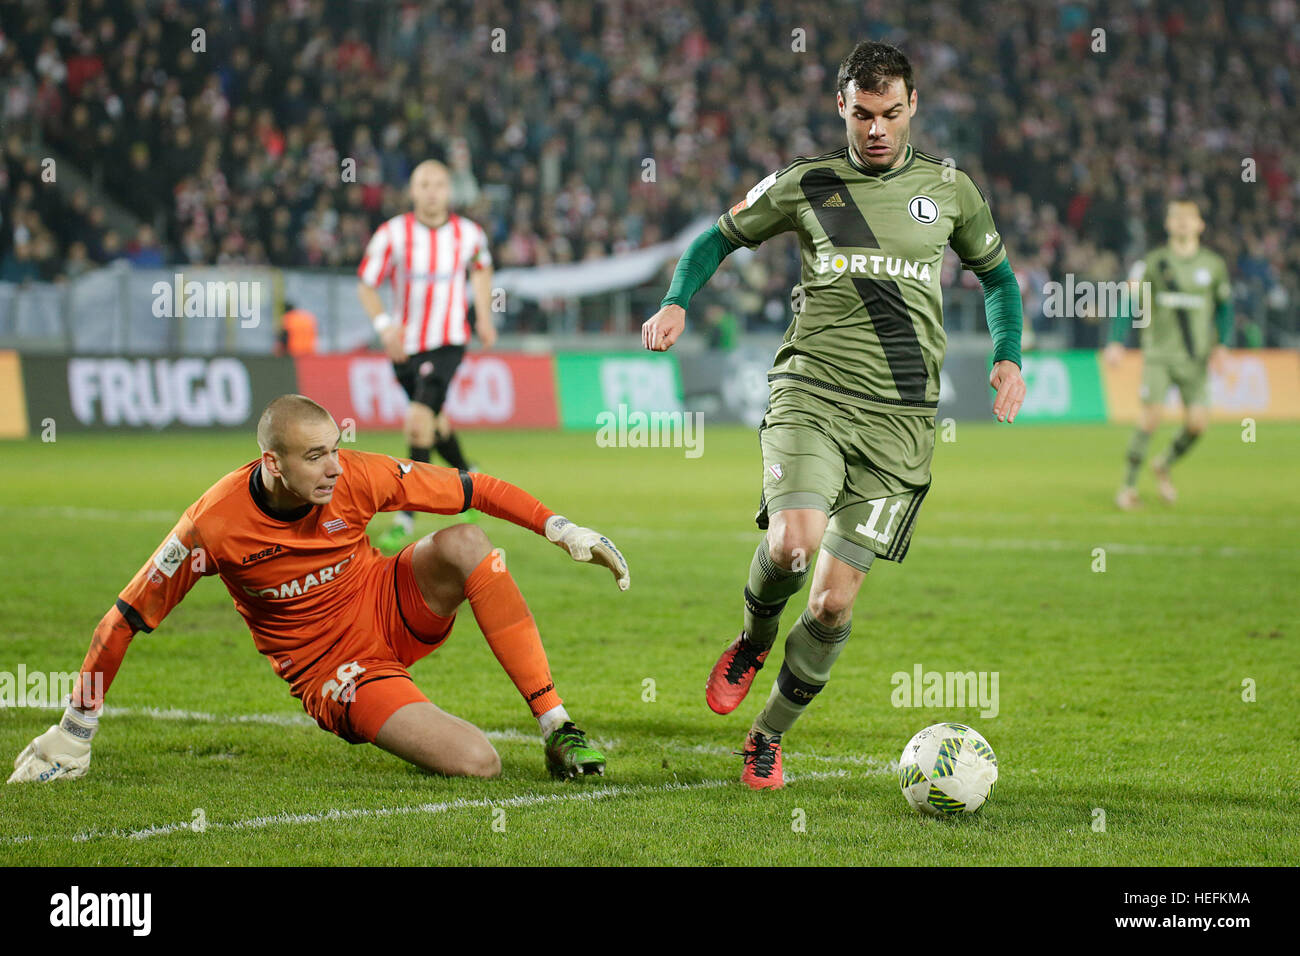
[352,451,632,591]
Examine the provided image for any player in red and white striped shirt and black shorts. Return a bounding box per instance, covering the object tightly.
[358,160,497,554]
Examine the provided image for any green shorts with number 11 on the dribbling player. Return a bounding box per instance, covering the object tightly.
[758,386,935,571]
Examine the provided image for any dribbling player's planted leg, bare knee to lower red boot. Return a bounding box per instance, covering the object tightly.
[741,549,866,790]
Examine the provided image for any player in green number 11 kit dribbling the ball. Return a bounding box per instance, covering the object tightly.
[641,43,1024,790]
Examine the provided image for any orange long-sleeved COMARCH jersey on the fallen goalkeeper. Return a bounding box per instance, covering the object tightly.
[96,450,553,697]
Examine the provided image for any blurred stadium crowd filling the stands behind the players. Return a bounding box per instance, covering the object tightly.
[0,0,1300,343]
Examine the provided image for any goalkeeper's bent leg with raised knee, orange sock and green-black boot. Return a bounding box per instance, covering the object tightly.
[412,524,605,778]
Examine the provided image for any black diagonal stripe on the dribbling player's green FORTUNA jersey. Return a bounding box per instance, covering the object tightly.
[800,166,930,402]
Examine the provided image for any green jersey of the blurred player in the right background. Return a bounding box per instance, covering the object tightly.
[1128,246,1232,362]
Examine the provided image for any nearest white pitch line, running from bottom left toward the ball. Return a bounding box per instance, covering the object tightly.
[5,770,850,843]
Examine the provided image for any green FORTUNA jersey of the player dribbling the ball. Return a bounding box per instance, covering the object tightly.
[718,146,1006,416]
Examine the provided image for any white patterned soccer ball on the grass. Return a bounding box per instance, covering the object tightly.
[898,723,997,817]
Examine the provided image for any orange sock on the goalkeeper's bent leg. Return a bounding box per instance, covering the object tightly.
[465,550,560,717]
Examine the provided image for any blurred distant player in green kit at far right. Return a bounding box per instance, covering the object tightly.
[1105,200,1232,511]
